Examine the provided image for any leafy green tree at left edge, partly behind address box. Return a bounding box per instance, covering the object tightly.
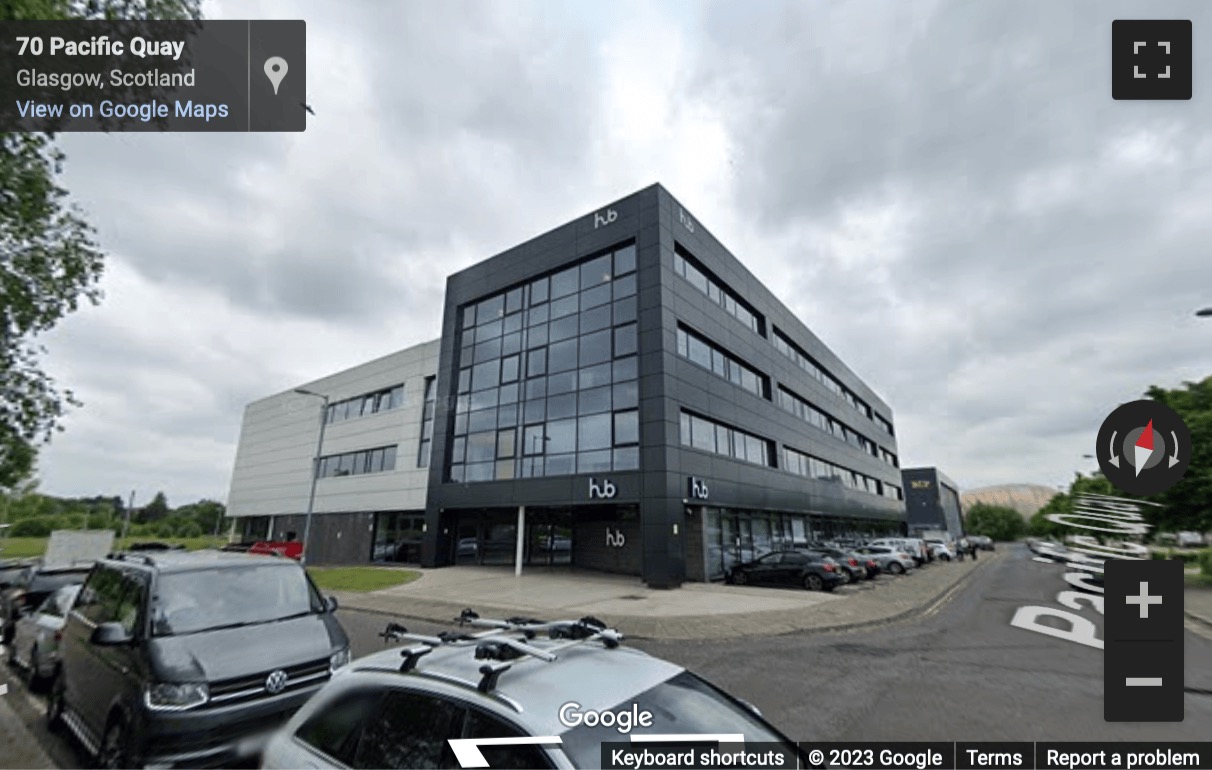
[0,0,201,486]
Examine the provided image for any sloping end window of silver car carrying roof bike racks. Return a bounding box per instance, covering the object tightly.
[560,672,787,768]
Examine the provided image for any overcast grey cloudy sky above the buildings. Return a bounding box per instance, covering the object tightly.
[30,0,1212,504]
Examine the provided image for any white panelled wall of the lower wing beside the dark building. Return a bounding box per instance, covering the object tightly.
[228,340,439,517]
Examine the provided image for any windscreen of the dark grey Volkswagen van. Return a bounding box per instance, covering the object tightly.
[152,563,324,637]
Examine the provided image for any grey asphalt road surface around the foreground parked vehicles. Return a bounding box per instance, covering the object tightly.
[0,547,1212,768]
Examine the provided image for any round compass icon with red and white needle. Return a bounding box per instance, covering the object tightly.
[1094,400,1191,497]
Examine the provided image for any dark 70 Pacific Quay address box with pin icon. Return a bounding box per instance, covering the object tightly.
[0,21,309,131]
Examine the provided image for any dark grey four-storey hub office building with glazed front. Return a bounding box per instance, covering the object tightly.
[230,186,905,588]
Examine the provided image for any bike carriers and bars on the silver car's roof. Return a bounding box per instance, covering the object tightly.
[379,609,623,694]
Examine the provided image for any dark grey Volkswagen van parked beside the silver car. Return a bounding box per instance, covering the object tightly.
[46,551,349,768]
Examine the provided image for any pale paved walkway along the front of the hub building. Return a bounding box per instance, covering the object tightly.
[337,552,1005,639]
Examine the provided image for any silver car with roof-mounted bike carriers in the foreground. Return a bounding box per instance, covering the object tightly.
[261,613,807,770]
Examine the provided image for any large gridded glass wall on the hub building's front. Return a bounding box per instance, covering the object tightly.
[446,245,640,483]
